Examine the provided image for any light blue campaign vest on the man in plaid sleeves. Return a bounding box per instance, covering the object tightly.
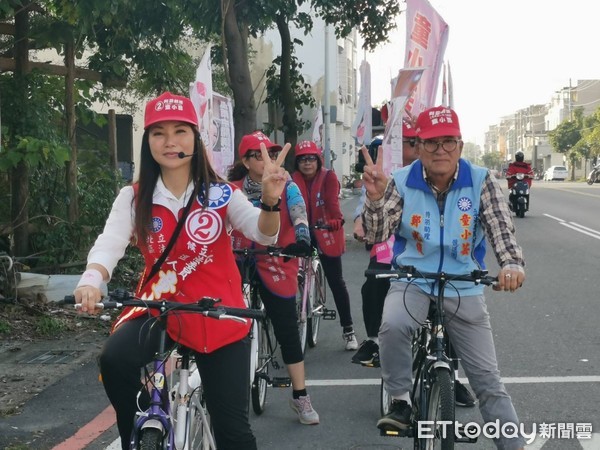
[392,159,488,297]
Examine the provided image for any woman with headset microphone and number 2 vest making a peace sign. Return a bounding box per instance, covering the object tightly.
[74,92,289,450]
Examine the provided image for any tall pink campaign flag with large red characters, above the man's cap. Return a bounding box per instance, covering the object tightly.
[404,0,449,117]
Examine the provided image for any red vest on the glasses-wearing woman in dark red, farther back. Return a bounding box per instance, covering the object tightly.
[292,168,346,257]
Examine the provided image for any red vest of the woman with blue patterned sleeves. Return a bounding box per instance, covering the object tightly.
[231,179,298,298]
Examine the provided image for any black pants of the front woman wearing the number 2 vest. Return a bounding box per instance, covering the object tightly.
[100,316,256,450]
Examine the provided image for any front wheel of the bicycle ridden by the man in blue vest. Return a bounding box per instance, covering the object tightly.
[421,367,454,450]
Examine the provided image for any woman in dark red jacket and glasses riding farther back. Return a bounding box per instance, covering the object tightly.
[292,141,358,351]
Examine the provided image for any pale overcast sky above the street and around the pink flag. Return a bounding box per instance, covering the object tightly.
[367,0,600,144]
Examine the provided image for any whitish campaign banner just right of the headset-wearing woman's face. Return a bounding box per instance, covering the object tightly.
[209,92,235,178]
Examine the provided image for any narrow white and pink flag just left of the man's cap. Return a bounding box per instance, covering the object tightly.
[381,67,424,176]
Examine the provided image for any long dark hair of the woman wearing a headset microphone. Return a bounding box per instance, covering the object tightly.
[133,125,224,242]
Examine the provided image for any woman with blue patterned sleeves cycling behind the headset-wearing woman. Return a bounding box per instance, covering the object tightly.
[229,131,319,425]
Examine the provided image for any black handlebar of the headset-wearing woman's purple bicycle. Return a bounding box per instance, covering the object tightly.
[62,292,265,323]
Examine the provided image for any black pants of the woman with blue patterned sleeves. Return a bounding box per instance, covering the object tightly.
[259,283,304,364]
